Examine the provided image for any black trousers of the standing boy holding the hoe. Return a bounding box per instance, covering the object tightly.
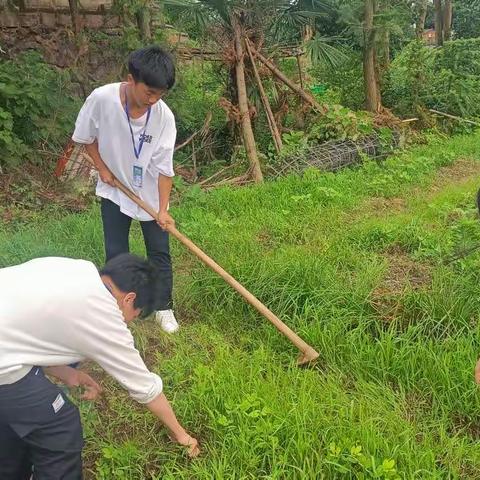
[101,198,173,310]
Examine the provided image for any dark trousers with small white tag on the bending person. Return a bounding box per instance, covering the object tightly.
[0,367,83,480]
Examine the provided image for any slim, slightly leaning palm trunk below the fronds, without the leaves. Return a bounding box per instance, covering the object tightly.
[230,13,263,183]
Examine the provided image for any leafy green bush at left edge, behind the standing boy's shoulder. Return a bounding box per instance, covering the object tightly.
[0,52,79,167]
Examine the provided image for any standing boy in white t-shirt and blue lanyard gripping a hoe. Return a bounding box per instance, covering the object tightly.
[72,46,178,333]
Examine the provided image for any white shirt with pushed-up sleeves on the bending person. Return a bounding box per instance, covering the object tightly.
[0,257,162,403]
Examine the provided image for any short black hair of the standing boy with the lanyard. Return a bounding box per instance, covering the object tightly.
[128,45,175,90]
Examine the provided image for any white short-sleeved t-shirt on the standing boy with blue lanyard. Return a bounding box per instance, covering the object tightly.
[72,83,177,221]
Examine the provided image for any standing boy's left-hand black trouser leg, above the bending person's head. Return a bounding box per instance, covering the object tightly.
[101,198,132,261]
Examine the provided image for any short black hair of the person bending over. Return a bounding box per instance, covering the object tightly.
[100,253,158,317]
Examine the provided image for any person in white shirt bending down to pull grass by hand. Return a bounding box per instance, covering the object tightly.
[0,254,199,480]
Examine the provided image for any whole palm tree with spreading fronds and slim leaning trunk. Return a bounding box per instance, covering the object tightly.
[162,0,342,182]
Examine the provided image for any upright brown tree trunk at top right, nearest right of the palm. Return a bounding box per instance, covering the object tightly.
[363,0,382,113]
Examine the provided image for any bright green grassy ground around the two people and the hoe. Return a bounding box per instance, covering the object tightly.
[0,134,480,480]
